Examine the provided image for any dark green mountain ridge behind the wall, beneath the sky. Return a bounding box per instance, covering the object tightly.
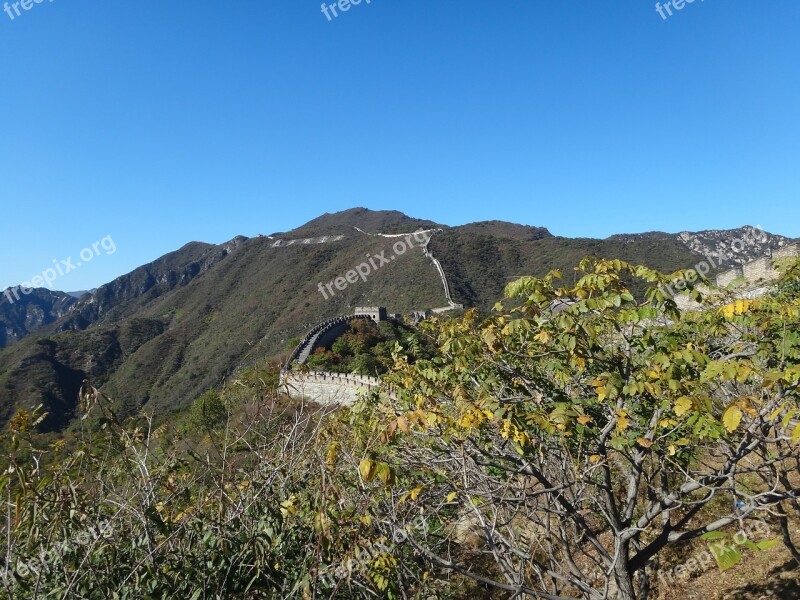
[0,208,788,429]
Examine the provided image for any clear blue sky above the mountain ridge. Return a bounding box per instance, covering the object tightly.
[0,0,800,290]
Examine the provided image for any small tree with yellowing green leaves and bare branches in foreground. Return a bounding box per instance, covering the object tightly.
[364,259,800,600]
